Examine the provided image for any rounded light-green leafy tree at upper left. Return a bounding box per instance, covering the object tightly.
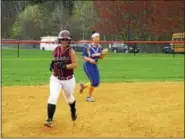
[12,5,50,39]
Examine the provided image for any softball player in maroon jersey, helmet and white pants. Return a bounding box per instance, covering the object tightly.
[44,30,78,127]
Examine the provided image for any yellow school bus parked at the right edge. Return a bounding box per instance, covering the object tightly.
[171,33,185,53]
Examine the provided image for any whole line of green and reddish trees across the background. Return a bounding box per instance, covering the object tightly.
[1,0,184,40]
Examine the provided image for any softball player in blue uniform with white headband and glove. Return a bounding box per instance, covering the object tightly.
[80,31,103,102]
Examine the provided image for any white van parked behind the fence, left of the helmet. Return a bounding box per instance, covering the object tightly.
[40,36,58,51]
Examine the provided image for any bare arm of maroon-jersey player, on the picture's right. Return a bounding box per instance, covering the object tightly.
[66,49,78,69]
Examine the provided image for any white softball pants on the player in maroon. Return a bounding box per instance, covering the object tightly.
[48,74,76,104]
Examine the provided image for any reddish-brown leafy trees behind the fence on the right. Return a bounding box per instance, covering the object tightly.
[94,0,184,39]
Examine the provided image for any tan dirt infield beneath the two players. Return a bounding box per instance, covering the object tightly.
[2,82,184,137]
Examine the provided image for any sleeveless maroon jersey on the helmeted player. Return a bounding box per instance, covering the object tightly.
[53,46,74,77]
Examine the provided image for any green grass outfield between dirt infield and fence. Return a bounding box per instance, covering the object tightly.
[2,49,184,86]
